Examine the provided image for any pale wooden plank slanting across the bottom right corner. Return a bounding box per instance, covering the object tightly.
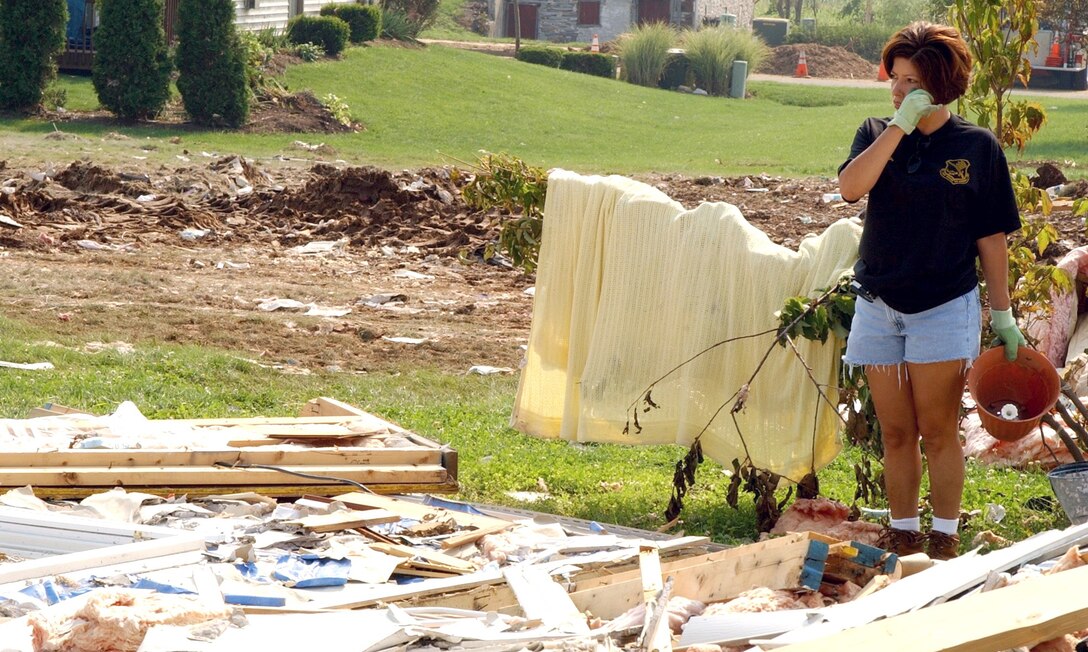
[779,566,1088,652]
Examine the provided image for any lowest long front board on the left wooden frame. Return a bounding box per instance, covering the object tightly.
[0,465,446,487]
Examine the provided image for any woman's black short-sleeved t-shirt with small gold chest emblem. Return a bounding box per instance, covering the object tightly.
[839,114,1021,313]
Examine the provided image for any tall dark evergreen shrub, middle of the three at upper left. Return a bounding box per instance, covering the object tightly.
[91,0,172,120]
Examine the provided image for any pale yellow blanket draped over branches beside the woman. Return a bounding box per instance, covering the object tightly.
[511,171,861,480]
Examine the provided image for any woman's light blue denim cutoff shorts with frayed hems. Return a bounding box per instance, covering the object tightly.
[842,287,982,366]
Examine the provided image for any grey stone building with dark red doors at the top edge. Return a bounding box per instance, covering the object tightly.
[489,0,755,44]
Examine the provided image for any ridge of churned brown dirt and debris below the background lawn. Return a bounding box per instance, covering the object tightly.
[0,155,498,256]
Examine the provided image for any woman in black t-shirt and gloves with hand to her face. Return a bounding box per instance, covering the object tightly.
[839,22,1024,559]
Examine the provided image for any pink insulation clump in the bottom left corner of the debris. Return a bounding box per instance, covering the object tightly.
[28,590,231,652]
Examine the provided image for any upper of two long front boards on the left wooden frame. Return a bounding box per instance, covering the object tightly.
[0,448,442,472]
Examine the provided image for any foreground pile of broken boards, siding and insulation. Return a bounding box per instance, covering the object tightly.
[0,476,1088,652]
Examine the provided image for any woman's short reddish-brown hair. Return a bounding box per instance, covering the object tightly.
[880,21,970,104]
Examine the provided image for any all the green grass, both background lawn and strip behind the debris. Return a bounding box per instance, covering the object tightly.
[8,47,1088,541]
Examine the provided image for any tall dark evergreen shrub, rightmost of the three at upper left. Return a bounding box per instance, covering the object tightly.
[176,0,249,127]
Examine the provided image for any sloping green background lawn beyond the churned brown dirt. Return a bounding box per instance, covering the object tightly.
[46,46,1088,176]
